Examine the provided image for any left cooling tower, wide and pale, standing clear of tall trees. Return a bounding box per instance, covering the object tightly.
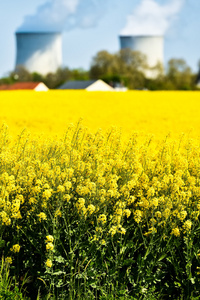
[16,32,62,75]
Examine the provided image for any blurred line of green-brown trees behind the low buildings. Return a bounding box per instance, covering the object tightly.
[0,49,200,90]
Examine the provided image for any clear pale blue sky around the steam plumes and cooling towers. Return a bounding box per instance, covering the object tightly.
[0,0,200,77]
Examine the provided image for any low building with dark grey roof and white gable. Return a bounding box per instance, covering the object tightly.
[58,79,114,91]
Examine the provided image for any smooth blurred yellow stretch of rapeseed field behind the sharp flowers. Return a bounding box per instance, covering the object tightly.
[0,91,200,135]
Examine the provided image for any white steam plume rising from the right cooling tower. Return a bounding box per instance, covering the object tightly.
[120,0,184,35]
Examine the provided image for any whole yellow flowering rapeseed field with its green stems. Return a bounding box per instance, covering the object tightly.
[0,91,200,300]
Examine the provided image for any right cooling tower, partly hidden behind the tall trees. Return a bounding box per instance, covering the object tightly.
[120,35,164,78]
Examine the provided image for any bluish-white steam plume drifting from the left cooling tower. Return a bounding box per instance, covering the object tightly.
[17,0,105,32]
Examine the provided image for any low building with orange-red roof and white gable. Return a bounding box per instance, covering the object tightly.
[0,82,49,92]
